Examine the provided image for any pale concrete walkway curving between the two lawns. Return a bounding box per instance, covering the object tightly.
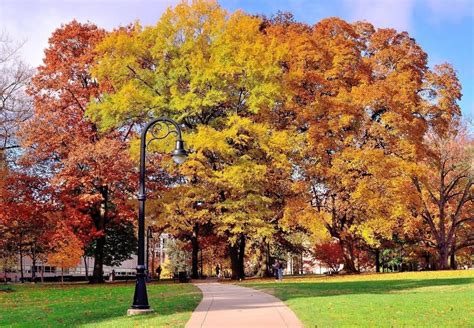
[186,283,303,328]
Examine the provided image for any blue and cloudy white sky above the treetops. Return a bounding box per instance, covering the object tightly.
[0,0,474,119]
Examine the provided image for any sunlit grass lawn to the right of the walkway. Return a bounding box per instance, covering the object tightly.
[243,270,474,327]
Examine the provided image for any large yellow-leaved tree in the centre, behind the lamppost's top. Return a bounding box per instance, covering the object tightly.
[88,1,292,277]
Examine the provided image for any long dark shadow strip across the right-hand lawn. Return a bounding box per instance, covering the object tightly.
[243,278,474,301]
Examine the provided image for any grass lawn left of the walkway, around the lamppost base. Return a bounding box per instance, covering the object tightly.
[0,283,201,328]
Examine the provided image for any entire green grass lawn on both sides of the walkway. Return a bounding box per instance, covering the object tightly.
[0,271,474,328]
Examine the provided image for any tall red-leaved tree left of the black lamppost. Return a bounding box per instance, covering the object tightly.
[21,21,135,283]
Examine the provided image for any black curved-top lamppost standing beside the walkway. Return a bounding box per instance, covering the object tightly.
[127,117,187,315]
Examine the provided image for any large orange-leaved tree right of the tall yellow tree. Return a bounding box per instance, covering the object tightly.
[265,16,460,272]
